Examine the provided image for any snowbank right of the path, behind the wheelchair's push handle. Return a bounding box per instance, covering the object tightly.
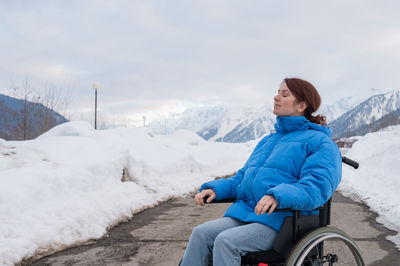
[339,126,400,249]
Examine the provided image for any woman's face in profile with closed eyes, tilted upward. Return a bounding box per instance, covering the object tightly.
[273,82,307,116]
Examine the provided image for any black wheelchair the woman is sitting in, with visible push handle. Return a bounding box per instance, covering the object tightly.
[181,157,365,266]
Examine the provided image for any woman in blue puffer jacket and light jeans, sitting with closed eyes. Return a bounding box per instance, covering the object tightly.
[181,78,342,266]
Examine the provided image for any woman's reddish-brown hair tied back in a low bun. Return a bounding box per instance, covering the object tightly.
[283,78,326,126]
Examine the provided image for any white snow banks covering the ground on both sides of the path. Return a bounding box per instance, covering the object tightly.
[0,122,400,265]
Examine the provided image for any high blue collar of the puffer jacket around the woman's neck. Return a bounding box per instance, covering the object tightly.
[275,116,332,137]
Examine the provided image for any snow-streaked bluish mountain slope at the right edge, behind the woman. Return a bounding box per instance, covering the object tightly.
[329,89,400,138]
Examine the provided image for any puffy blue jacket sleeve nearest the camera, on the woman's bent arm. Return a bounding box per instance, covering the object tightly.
[266,139,342,211]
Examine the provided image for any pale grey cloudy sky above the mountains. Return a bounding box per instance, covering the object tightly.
[0,0,400,126]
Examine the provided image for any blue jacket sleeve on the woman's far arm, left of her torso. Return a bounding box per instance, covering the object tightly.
[200,135,271,200]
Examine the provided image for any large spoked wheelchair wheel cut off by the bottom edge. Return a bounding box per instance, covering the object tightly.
[286,227,365,266]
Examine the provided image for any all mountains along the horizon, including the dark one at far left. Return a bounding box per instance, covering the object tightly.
[0,89,400,142]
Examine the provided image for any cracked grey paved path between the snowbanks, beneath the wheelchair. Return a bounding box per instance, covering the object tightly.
[29,193,400,266]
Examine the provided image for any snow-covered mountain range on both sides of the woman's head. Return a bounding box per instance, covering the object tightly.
[148,89,400,142]
